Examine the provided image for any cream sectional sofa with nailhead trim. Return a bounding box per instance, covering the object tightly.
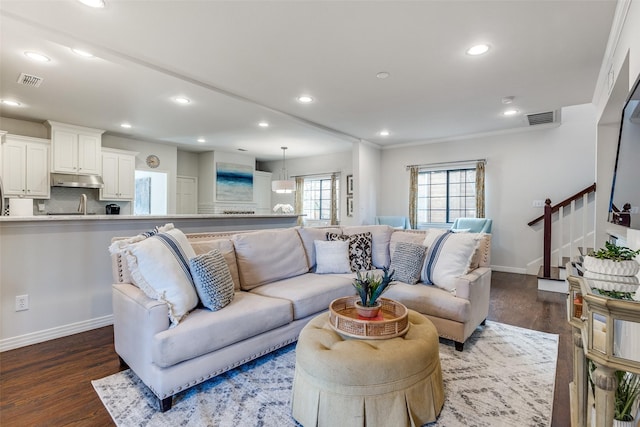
[110,225,491,411]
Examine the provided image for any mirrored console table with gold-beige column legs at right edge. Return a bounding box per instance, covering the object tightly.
[567,263,640,427]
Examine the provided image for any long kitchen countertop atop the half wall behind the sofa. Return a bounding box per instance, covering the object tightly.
[0,214,300,222]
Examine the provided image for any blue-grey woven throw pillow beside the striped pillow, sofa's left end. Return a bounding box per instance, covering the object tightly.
[189,249,234,311]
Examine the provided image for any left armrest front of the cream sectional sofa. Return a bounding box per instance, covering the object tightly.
[112,283,170,373]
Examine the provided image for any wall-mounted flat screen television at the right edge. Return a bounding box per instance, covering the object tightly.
[609,73,640,229]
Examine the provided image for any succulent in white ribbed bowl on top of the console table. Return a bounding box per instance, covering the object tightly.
[583,242,640,276]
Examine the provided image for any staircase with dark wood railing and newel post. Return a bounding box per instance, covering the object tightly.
[528,184,596,293]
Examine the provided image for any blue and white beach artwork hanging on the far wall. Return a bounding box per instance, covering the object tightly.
[216,162,253,202]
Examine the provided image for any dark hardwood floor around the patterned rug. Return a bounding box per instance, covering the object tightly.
[0,272,572,427]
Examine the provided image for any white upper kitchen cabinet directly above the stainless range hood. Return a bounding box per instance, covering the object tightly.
[45,121,104,175]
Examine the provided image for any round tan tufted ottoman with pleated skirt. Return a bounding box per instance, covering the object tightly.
[291,310,444,427]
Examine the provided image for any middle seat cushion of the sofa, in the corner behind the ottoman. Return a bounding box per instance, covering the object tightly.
[251,273,355,320]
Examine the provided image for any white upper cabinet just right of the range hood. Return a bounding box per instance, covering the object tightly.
[100,148,138,200]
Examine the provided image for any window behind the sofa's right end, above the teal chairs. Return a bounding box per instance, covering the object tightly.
[417,168,476,224]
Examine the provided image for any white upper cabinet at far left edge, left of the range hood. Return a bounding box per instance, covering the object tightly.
[2,134,51,199]
